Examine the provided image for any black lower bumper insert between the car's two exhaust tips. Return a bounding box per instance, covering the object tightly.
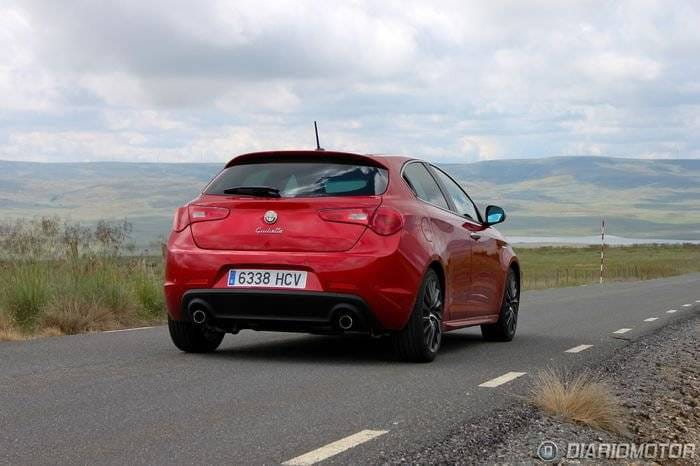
[182,289,377,332]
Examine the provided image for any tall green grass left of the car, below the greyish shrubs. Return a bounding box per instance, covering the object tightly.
[0,257,165,340]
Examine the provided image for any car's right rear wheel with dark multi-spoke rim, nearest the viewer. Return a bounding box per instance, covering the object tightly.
[392,270,443,362]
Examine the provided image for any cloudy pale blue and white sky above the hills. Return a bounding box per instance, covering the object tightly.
[0,0,700,162]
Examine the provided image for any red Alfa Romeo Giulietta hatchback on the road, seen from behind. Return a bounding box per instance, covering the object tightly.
[165,151,520,361]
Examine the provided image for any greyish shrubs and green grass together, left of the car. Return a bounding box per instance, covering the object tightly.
[0,218,165,340]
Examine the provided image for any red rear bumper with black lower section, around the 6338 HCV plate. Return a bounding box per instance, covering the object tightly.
[164,224,425,330]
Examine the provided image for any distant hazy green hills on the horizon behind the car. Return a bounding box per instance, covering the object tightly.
[0,157,700,244]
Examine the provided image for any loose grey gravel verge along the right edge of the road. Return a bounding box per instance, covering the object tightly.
[386,314,700,464]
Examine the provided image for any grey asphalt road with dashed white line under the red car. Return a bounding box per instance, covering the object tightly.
[0,274,700,464]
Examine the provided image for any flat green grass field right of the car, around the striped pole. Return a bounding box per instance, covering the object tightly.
[517,244,700,290]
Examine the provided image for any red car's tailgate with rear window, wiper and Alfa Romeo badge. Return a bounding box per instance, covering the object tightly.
[189,155,388,252]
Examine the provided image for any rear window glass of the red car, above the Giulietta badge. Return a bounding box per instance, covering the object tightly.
[204,160,389,197]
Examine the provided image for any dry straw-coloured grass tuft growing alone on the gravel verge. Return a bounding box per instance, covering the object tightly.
[531,369,626,433]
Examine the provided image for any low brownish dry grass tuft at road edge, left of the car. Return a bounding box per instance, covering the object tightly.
[40,296,115,336]
